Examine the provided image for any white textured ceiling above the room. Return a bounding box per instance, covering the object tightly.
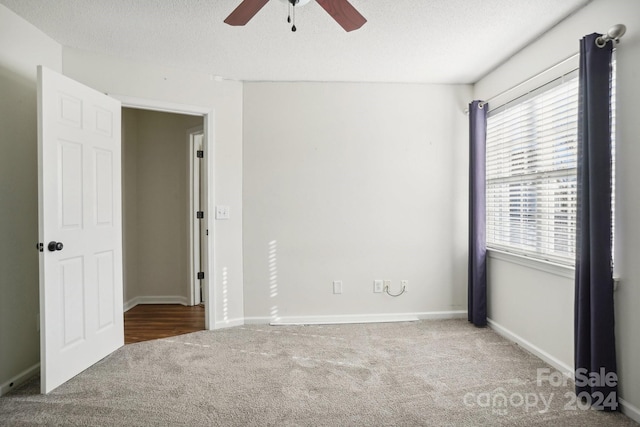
[0,0,590,83]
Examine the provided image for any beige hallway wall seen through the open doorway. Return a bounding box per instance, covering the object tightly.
[122,108,203,306]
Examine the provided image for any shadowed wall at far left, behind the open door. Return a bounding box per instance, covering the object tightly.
[0,5,62,394]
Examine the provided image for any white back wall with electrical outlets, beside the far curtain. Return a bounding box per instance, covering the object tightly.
[243,83,471,321]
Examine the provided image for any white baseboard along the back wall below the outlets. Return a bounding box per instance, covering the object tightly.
[244,311,467,326]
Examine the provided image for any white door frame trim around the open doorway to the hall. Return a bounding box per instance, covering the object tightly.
[112,93,217,330]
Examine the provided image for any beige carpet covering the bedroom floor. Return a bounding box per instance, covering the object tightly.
[0,320,635,427]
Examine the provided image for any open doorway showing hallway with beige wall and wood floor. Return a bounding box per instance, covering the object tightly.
[122,107,206,339]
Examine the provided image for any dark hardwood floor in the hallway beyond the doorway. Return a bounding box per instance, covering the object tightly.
[124,304,204,344]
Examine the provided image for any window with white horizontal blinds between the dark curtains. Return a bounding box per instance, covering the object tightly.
[486,67,615,265]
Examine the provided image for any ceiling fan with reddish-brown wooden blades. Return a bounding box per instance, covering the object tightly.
[224,0,367,31]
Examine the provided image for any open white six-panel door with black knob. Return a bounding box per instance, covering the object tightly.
[38,67,124,393]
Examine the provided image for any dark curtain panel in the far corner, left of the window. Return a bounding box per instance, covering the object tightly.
[467,101,489,326]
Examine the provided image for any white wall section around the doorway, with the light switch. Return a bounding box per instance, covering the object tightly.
[63,47,243,327]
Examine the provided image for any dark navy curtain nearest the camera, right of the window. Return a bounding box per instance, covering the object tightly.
[575,34,618,411]
